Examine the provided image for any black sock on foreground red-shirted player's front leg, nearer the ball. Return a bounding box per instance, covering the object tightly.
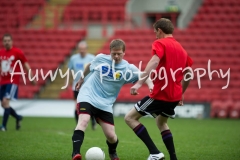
[133,123,160,154]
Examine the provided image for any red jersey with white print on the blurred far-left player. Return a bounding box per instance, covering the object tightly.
[0,47,27,85]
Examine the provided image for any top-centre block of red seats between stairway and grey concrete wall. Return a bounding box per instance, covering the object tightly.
[63,0,127,23]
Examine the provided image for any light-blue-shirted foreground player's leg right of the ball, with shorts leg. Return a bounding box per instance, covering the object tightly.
[96,109,119,160]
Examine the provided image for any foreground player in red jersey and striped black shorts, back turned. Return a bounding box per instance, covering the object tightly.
[125,18,193,160]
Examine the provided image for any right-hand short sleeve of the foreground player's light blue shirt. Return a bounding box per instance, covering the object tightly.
[125,64,140,84]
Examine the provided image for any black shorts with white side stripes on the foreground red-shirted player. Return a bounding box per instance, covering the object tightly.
[134,96,179,118]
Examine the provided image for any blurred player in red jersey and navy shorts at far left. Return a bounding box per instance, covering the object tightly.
[0,34,36,131]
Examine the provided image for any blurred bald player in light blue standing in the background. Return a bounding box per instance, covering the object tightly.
[68,41,96,130]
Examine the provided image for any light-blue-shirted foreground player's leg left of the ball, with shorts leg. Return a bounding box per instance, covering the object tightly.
[72,102,92,160]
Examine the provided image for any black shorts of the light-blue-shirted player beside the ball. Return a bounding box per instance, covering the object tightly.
[77,102,114,125]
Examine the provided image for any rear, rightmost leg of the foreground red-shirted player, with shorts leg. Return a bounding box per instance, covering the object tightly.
[156,102,178,160]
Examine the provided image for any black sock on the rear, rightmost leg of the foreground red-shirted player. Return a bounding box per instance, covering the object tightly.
[161,130,177,160]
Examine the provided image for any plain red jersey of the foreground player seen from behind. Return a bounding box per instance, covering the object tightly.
[149,37,193,102]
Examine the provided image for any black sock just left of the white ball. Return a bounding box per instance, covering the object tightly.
[72,130,84,154]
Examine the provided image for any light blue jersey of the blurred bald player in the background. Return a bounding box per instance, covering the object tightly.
[68,53,95,90]
